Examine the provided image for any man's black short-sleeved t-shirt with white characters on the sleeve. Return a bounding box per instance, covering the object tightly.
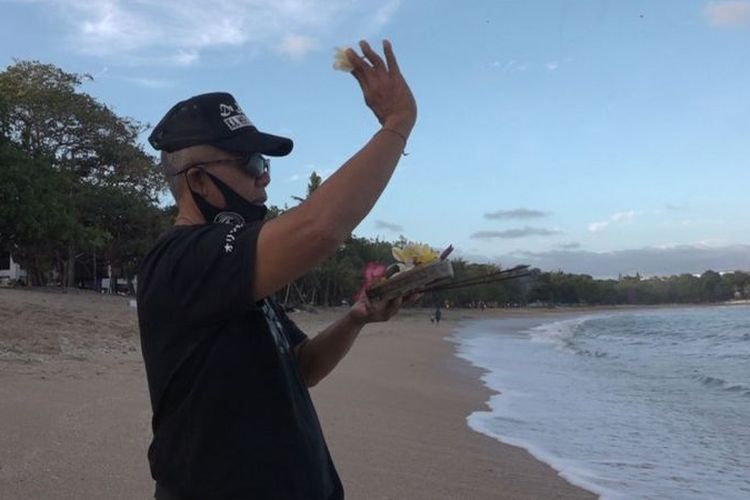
[138,223,343,500]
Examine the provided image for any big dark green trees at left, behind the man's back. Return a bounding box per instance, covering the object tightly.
[0,61,171,287]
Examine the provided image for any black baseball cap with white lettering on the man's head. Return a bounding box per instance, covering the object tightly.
[148,92,294,156]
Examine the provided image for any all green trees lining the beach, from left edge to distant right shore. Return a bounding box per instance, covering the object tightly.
[0,61,750,307]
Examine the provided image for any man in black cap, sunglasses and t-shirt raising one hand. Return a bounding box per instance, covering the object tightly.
[138,41,416,500]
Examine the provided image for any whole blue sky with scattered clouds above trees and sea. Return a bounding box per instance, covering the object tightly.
[0,0,750,276]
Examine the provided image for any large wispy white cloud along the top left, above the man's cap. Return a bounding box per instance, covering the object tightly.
[11,0,400,65]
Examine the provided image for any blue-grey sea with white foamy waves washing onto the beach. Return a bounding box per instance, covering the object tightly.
[453,306,750,500]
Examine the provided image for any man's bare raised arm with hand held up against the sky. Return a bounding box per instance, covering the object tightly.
[253,41,417,300]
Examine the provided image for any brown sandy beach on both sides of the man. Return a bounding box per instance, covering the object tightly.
[0,290,595,499]
